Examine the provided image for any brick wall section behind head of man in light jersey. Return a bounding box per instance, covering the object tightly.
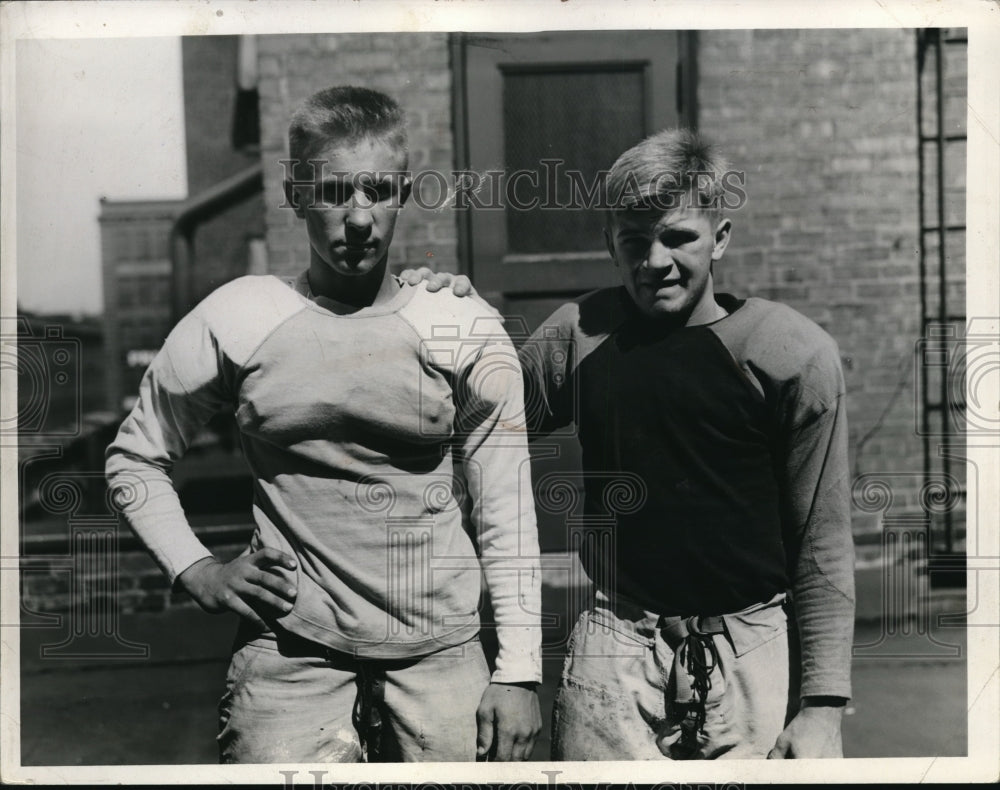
[259,33,458,282]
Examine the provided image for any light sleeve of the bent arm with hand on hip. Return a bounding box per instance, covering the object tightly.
[105,313,227,583]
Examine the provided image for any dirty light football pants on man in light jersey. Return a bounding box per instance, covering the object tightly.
[218,634,489,763]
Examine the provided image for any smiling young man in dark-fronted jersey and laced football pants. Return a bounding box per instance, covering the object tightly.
[402,130,854,760]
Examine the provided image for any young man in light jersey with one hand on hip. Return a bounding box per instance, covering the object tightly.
[107,87,541,763]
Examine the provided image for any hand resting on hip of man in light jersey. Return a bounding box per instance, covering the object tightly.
[177,548,298,628]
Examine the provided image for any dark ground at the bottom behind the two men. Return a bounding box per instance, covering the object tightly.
[21,576,967,765]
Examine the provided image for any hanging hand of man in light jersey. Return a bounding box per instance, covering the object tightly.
[476,683,542,762]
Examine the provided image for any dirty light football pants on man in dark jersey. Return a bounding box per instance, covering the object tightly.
[552,592,789,760]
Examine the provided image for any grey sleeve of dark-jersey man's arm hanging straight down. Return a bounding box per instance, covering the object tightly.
[780,341,855,697]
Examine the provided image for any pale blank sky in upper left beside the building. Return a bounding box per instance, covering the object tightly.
[16,37,187,313]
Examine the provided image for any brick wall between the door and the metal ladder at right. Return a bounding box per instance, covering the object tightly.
[698,30,965,552]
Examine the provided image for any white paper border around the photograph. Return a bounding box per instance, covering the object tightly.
[0,0,1000,785]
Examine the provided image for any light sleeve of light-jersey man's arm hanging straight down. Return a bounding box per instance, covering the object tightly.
[456,330,542,683]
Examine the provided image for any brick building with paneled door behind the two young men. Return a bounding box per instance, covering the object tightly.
[90,29,966,620]
